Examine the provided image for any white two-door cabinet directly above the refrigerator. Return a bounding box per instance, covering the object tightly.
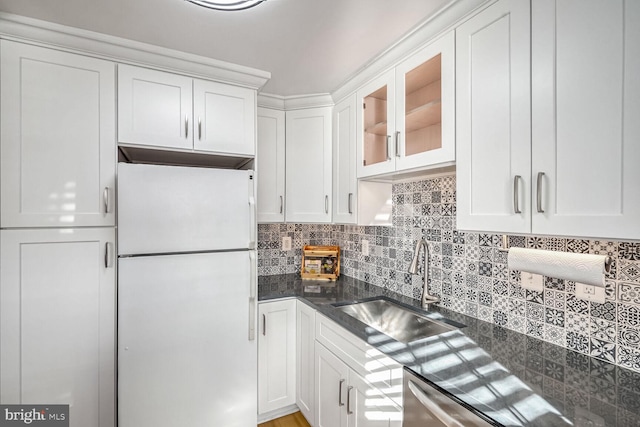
[118,64,256,156]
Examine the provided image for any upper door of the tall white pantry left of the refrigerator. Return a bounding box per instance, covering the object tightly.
[0,40,116,228]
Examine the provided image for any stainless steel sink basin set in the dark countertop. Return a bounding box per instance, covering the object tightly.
[336,299,464,344]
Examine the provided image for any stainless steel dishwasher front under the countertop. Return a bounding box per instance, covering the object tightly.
[402,368,494,427]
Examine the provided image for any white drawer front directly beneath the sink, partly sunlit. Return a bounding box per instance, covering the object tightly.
[316,314,402,405]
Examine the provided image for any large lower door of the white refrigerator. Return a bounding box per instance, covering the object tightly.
[118,251,257,427]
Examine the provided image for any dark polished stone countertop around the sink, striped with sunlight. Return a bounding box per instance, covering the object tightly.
[258,274,640,427]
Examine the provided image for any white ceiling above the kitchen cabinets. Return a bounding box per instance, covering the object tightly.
[0,0,451,96]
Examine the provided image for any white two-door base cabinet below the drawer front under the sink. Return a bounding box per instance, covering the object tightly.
[315,342,402,427]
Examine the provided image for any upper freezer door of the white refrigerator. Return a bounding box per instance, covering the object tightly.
[118,163,255,255]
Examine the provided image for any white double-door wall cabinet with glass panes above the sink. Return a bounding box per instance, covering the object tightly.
[357,33,455,178]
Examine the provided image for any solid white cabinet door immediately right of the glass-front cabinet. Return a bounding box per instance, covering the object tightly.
[456,0,531,233]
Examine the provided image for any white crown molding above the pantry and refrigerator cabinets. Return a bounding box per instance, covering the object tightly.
[0,12,271,90]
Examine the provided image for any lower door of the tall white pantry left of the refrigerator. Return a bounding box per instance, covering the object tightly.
[0,228,115,427]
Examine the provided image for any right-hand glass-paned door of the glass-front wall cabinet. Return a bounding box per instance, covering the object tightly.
[394,31,456,170]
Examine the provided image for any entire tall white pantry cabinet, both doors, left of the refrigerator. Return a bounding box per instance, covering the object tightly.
[0,40,116,427]
